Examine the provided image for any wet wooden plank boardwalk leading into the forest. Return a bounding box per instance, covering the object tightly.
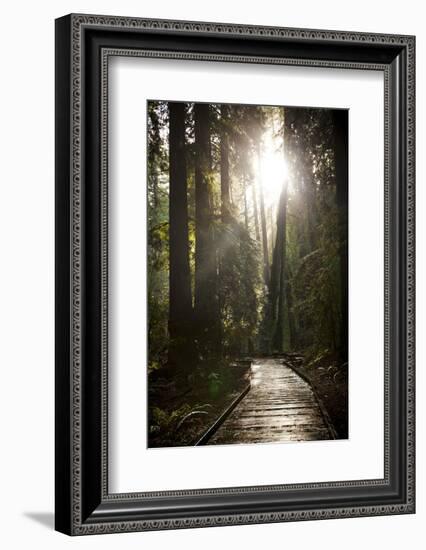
[208,359,333,445]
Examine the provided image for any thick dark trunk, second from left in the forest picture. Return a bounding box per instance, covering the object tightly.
[194,103,219,358]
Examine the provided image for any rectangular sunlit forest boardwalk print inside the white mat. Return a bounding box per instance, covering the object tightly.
[147,100,349,448]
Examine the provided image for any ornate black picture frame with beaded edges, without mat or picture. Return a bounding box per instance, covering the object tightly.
[56,15,415,535]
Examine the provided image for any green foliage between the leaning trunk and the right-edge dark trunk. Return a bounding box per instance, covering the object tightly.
[282,117,347,354]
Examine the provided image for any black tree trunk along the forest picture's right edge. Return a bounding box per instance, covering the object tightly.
[333,109,349,361]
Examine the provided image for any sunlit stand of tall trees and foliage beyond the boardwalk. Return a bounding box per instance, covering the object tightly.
[148,101,348,450]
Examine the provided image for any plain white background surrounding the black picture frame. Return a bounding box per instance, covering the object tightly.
[0,0,426,550]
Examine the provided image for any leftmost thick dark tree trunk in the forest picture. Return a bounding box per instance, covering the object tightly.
[169,103,192,368]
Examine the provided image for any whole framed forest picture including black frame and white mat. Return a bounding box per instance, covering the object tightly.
[55,14,415,535]
